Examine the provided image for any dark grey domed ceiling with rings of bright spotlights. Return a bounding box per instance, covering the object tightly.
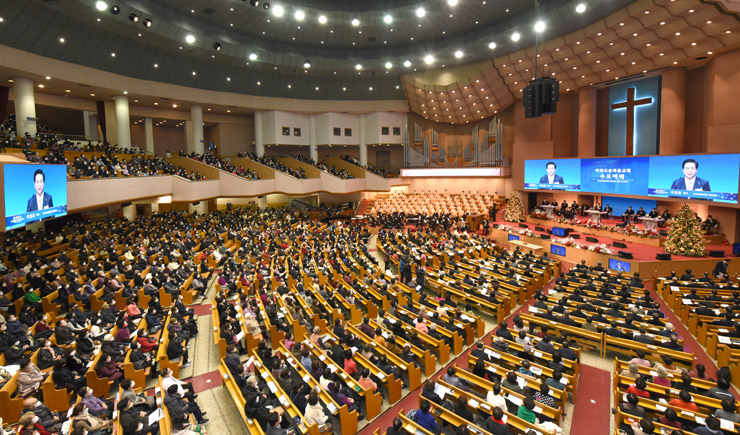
[0,0,630,100]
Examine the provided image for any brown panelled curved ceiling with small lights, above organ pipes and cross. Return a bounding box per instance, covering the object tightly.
[403,0,740,124]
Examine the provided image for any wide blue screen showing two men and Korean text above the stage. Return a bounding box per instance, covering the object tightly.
[524,154,740,204]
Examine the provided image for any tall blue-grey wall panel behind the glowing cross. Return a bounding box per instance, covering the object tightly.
[609,76,661,156]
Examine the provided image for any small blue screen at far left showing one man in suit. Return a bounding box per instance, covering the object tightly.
[3,164,67,230]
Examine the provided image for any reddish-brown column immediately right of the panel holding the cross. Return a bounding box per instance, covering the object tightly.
[659,68,686,154]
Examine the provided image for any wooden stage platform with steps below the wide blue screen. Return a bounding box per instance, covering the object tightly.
[489,220,740,279]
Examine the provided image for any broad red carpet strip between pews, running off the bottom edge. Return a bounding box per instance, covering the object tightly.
[570,364,611,435]
